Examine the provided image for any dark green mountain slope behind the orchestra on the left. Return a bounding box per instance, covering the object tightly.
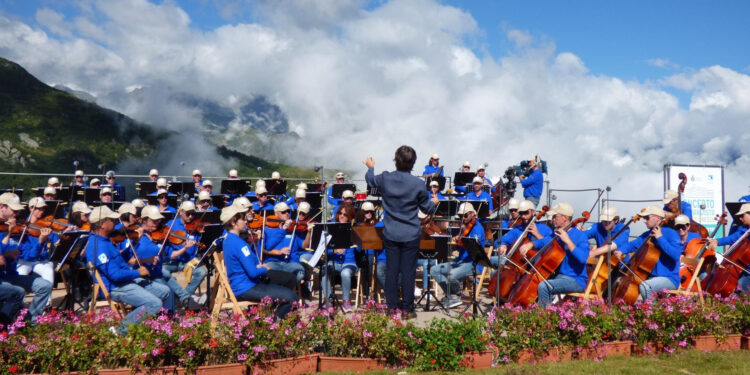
[0,58,316,195]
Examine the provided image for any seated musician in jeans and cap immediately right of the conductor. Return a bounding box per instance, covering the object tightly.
[430,203,484,308]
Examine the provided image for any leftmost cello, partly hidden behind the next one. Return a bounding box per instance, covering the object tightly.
[487,206,549,300]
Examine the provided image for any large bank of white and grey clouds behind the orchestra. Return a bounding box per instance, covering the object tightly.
[0,0,750,217]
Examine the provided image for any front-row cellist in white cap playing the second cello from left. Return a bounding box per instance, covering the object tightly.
[519,202,589,307]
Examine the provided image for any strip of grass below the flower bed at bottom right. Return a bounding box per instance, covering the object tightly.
[356,350,750,375]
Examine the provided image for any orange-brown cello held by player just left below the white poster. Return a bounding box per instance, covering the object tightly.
[613,217,663,305]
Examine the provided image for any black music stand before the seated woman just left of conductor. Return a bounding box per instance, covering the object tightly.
[310,223,356,313]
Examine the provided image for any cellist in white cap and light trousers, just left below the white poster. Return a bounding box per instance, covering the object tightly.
[621,206,682,299]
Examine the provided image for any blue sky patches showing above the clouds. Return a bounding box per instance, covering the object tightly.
[0,0,750,81]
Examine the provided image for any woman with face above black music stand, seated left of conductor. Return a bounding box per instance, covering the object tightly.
[321,204,359,313]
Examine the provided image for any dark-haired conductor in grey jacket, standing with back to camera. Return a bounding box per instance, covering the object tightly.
[364,146,438,318]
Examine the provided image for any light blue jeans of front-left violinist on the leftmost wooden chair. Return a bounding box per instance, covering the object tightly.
[109,278,172,333]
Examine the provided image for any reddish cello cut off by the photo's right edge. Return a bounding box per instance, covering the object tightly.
[701,226,750,297]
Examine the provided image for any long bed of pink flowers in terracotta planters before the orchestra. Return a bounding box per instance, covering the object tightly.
[0,296,750,375]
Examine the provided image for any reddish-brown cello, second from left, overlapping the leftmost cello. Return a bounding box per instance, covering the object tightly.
[508,211,591,307]
